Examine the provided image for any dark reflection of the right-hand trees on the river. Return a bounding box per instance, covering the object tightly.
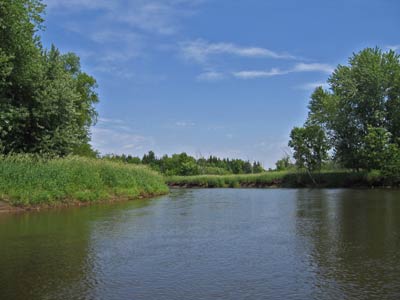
[297,190,400,299]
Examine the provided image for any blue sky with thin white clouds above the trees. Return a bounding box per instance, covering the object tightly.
[42,0,400,168]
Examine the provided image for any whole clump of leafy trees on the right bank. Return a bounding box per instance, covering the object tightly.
[289,48,400,182]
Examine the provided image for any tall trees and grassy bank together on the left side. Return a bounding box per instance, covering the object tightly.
[0,0,168,205]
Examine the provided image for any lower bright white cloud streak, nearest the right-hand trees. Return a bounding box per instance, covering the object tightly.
[232,63,334,79]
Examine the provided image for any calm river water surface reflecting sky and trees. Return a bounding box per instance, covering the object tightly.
[0,189,400,299]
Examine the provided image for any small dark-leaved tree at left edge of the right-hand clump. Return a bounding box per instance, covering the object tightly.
[289,125,329,173]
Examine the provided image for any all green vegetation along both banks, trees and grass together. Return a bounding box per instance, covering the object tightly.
[0,0,400,209]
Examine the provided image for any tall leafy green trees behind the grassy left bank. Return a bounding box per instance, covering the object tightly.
[0,0,99,156]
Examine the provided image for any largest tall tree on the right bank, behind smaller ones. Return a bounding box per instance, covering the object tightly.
[306,48,400,169]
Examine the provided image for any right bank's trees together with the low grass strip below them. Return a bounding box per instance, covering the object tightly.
[167,48,400,187]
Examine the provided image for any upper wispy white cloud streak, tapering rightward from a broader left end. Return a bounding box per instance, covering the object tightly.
[180,39,296,63]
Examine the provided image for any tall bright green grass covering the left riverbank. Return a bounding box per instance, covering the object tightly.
[0,155,168,206]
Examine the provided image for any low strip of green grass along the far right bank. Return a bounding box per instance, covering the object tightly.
[166,171,383,188]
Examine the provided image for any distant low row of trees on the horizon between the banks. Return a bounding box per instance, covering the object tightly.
[104,151,265,176]
